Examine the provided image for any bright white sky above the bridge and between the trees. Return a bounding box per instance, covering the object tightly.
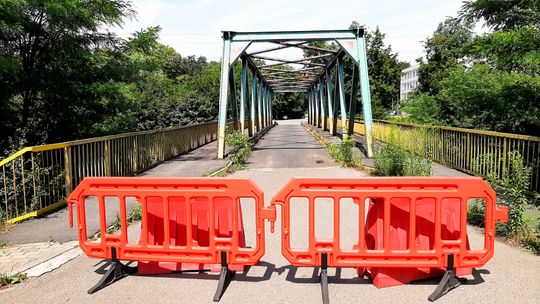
[113,0,472,63]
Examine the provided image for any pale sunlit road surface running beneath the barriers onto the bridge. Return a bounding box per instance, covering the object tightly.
[0,120,540,304]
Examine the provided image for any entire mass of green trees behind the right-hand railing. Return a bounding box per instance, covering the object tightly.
[408,0,540,134]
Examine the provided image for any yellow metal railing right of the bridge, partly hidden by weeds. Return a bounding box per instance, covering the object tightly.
[344,120,540,193]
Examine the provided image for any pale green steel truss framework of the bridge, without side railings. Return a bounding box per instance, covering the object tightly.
[217,27,373,159]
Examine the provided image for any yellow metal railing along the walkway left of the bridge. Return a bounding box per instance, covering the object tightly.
[0,121,231,223]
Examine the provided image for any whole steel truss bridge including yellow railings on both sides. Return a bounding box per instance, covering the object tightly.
[0,28,540,223]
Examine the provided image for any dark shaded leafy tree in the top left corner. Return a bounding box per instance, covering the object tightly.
[0,0,133,150]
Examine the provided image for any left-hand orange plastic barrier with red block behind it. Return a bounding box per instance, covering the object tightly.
[68,177,276,301]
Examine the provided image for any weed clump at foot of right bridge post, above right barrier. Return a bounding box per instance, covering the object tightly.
[373,129,432,176]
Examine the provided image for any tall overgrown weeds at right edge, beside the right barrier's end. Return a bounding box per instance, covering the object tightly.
[468,151,540,254]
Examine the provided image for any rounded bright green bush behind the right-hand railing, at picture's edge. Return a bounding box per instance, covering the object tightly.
[437,64,540,133]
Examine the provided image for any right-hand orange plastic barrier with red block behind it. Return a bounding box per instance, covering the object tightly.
[272,177,508,303]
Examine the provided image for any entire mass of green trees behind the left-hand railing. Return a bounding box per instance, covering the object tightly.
[0,0,220,152]
